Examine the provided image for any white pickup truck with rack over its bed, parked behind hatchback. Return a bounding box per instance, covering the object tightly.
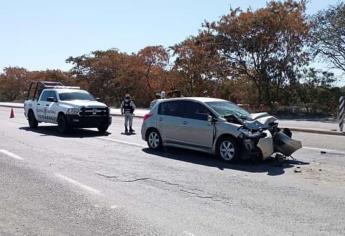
[24,81,111,133]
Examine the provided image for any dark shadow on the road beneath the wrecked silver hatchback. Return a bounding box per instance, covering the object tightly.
[143,147,309,176]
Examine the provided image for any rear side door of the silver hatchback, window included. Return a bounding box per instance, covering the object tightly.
[157,101,183,144]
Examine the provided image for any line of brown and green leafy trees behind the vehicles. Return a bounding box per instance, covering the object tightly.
[0,0,345,114]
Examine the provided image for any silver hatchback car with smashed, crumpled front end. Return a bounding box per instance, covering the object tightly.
[141,97,302,161]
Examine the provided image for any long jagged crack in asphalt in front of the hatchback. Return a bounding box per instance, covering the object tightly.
[96,173,230,204]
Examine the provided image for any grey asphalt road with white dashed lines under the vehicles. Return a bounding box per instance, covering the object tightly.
[0,108,345,235]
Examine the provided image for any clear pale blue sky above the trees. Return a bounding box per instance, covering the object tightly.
[0,0,338,70]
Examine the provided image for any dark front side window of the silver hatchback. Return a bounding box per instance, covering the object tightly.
[183,101,212,121]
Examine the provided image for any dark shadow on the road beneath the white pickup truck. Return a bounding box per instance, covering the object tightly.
[19,126,110,138]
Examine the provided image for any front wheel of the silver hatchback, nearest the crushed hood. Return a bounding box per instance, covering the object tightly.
[217,137,239,162]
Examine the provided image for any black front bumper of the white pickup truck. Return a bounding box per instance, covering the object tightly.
[67,115,112,128]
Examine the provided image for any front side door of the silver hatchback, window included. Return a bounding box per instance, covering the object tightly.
[180,101,214,150]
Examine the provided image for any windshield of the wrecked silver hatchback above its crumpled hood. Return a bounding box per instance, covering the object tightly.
[206,101,250,120]
